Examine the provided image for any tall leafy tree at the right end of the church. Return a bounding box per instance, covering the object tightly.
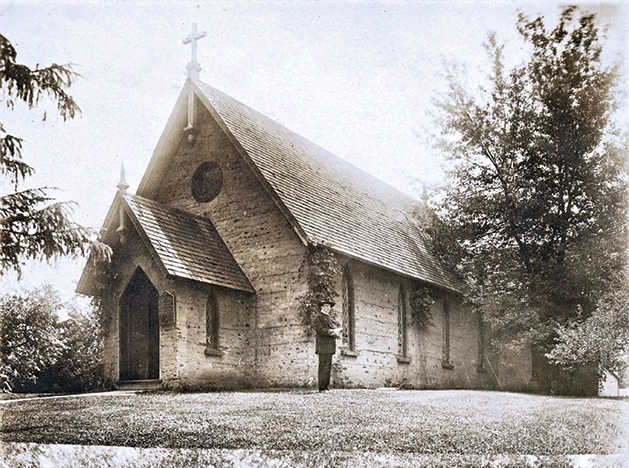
[430,7,628,366]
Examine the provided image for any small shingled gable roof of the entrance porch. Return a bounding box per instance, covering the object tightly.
[77,193,255,294]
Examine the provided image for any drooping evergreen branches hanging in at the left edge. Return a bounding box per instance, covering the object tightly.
[0,34,109,275]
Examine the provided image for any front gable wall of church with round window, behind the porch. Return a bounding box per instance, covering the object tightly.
[154,101,316,386]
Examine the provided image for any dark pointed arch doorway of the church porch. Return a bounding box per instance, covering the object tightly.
[119,267,159,381]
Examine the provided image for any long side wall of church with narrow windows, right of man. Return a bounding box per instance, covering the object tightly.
[333,262,530,389]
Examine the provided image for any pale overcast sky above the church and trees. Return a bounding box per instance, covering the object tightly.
[0,0,629,299]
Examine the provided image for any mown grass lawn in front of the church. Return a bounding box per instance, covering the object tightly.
[0,390,629,455]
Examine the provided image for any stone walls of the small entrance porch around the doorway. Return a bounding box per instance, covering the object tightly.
[102,208,254,388]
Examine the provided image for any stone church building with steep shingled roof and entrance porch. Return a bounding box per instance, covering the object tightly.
[77,28,534,390]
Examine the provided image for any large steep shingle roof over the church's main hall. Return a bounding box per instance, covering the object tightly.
[191,82,459,290]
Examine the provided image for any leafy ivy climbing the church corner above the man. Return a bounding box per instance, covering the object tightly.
[298,244,340,335]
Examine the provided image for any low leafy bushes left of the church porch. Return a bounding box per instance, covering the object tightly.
[0,286,105,392]
